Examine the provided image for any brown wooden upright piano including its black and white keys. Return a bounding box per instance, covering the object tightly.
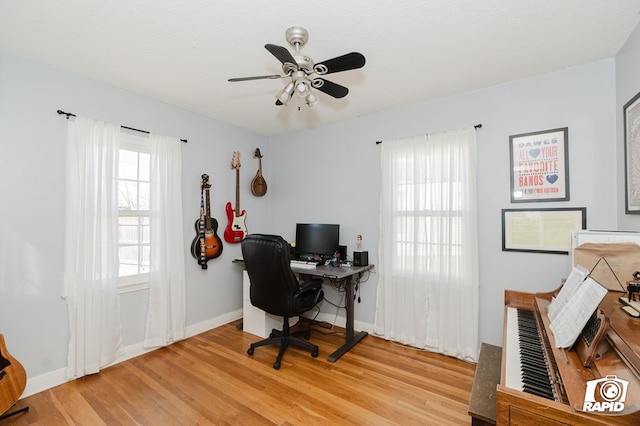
[496,290,640,426]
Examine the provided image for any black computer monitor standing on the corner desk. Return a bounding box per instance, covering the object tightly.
[295,223,340,260]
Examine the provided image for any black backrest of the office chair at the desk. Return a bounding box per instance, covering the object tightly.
[241,234,300,317]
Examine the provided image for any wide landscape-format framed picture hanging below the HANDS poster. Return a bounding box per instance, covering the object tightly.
[502,207,587,254]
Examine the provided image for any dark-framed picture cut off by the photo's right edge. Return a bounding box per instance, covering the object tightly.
[623,93,640,214]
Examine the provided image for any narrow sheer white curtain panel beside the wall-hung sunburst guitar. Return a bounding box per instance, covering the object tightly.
[145,134,186,347]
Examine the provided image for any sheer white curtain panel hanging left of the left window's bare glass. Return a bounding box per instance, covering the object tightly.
[64,117,122,378]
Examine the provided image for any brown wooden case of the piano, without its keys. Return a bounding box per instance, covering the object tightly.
[496,290,640,426]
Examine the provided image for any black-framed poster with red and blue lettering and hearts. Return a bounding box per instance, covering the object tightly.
[509,127,568,202]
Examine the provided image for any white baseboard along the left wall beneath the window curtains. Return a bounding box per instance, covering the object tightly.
[20,309,242,399]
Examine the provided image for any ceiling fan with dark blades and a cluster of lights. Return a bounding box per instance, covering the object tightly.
[229,27,365,107]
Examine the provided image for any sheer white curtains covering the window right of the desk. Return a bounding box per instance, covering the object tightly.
[374,127,479,361]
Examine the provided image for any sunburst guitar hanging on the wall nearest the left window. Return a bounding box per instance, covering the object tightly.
[191,174,223,269]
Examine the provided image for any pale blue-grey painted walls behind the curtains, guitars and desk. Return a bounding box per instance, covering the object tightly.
[0,27,640,396]
